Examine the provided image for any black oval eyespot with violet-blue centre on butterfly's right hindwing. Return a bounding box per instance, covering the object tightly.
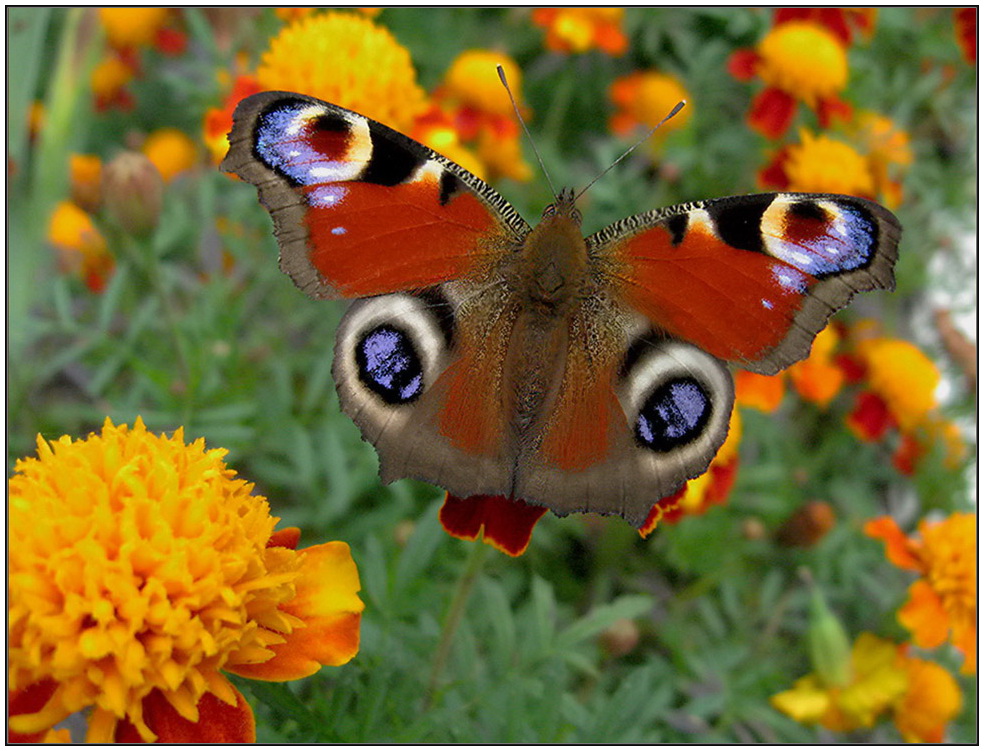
[635,378,711,453]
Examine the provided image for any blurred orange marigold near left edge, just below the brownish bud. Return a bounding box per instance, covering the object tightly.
[48,201,116,292]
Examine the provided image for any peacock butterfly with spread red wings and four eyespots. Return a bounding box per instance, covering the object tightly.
[222,92,901,526]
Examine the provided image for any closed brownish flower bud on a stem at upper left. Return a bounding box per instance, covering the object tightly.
[103,151,164,235]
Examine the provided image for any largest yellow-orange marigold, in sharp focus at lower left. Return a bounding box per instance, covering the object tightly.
[7,418,363,743]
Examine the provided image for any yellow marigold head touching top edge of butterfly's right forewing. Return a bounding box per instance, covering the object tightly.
[780,131,875,197]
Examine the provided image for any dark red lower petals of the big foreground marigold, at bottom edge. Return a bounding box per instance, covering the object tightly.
[116,686,256,745]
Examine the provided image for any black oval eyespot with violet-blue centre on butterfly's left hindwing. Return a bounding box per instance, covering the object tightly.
[355,324,424,404]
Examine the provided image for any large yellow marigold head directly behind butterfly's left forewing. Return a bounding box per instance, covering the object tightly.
[256,13,427,131]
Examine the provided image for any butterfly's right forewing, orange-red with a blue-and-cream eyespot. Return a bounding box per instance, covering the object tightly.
[588,193,901,374]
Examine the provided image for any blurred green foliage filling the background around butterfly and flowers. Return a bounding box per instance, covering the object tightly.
[7,8,977,743]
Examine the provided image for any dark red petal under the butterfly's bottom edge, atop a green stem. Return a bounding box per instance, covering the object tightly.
[439,493,547,556]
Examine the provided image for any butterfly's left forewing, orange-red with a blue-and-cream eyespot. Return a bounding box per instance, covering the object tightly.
[222,91,529,298]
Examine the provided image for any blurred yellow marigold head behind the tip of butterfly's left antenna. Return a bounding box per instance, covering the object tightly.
[441,50,523,119]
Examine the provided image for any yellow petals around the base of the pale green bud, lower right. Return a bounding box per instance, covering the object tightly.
[771,633,908,732]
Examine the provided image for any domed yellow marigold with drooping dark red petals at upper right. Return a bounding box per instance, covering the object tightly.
[728,21,850,139]
